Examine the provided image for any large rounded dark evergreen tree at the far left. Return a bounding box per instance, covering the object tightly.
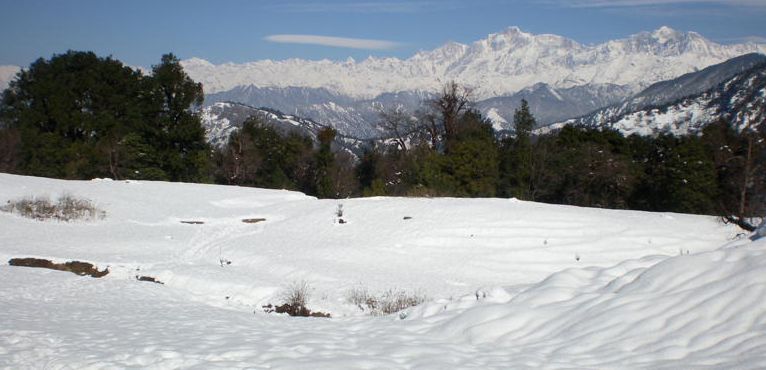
[0,51,145,178]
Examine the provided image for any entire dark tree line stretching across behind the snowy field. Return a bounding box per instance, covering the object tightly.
[0,51,766,227]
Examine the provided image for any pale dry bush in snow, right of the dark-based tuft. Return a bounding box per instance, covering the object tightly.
[346,287,426,316]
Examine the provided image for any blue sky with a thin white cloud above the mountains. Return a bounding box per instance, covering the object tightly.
[0,0,766,67]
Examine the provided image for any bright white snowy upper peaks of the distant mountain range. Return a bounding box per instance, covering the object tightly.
[182,27,766,100]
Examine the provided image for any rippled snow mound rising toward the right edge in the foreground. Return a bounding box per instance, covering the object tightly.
[411,241,766,369]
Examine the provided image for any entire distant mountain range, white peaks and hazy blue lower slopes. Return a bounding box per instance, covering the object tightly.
[188,27,766,139]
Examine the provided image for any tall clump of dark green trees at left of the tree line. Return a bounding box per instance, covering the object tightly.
[0,51,208,181]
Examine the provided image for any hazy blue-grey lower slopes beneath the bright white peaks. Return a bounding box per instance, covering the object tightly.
[206,83,633,139]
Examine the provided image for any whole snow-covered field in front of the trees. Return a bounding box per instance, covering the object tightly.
[0,174,766,369]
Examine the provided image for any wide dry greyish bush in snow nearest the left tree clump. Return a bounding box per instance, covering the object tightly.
[0,194,106,222]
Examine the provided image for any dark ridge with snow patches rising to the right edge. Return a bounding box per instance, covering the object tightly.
[541,55,766,135]
